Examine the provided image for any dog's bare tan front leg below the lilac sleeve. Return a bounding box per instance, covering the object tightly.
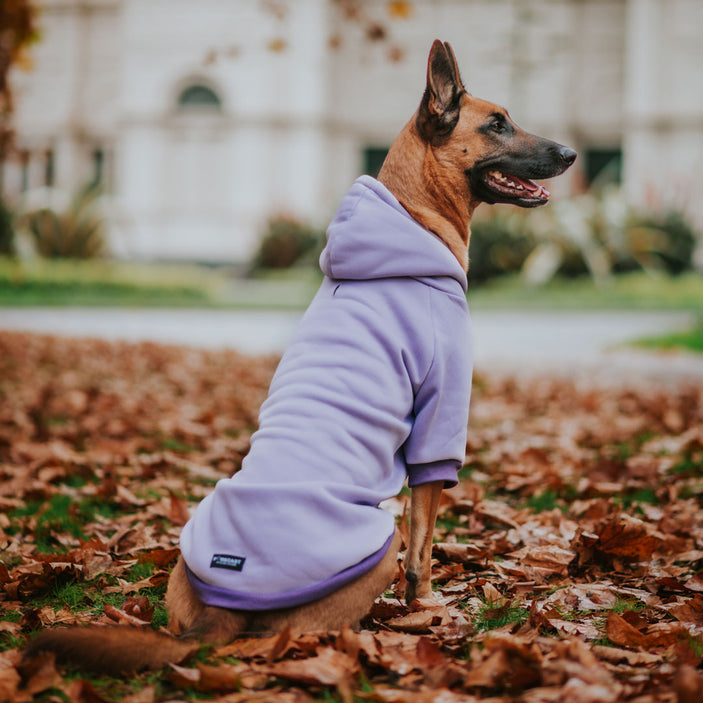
[405,481,444,603]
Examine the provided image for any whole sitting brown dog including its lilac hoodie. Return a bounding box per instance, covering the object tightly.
[25,40,576,673]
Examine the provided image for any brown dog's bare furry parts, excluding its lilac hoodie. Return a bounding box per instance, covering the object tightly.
[26,41,576,673]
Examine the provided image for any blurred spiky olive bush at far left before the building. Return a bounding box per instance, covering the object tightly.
[22,188,107,259]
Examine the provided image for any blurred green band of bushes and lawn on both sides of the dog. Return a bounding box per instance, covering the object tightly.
[0,186,703,315]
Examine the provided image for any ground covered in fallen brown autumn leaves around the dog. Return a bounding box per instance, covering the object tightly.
[0,333,703,703]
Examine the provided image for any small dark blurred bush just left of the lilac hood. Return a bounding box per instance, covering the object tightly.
[254,215,324,269]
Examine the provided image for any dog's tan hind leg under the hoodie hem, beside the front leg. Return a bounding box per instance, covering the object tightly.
[250,530,401,632]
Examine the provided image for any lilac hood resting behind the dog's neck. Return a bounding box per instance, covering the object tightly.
[320,176,467,293]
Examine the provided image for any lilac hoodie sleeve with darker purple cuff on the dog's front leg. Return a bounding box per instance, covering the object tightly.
[404,295,472,488]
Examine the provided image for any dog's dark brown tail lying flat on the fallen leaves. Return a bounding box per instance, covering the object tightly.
[24,625,200,676]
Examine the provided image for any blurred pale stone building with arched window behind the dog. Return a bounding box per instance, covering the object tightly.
[2,0,703,261]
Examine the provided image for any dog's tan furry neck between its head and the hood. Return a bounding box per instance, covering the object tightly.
[378,118,476,271]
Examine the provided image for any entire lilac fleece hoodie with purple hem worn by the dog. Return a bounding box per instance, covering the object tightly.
[181,176,471,610]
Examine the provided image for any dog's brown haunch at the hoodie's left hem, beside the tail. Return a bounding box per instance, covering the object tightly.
[166,557,251,644]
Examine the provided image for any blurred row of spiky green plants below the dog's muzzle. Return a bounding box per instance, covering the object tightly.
[469,187,697,285]
